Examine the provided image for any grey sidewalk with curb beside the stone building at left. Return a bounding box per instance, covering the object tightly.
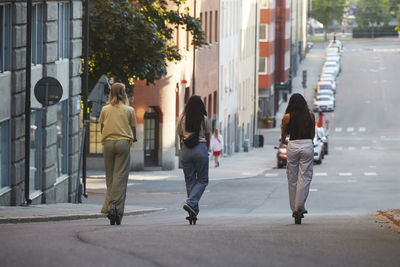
[0,203,163,224]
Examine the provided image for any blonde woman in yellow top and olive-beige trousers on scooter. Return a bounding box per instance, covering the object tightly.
[99,83,137,225]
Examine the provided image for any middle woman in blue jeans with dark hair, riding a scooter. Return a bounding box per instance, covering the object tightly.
[176,95,211,224]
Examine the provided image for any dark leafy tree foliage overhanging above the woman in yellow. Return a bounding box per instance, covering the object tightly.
[89,0,206,88]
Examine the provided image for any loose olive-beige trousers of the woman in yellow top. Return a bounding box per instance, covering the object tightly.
[101,140,131,214]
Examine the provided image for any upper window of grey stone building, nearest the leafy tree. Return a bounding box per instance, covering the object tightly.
[57,3,70,59]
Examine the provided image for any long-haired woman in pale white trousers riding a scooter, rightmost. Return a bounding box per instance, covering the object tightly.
[281,94,315,224]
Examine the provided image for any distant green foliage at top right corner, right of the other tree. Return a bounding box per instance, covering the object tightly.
[357,0,391,28]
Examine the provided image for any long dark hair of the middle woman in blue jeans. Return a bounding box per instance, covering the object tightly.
[183,95,207,132]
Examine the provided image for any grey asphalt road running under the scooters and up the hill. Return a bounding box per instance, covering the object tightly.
[0,39,400,266]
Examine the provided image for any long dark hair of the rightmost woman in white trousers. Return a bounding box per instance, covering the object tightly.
[285,93,314,136]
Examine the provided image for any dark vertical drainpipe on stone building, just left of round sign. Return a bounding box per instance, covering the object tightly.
[25,0,32,205]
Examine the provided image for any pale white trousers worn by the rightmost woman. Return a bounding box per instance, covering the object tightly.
[286,139,314,211]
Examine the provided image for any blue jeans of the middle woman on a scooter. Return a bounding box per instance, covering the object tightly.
[181,143,208,213]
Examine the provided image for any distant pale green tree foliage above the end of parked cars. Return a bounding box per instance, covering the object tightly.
[312,0,346,30]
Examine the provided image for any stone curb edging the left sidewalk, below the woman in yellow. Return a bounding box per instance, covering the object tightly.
[0,209,165,224]
